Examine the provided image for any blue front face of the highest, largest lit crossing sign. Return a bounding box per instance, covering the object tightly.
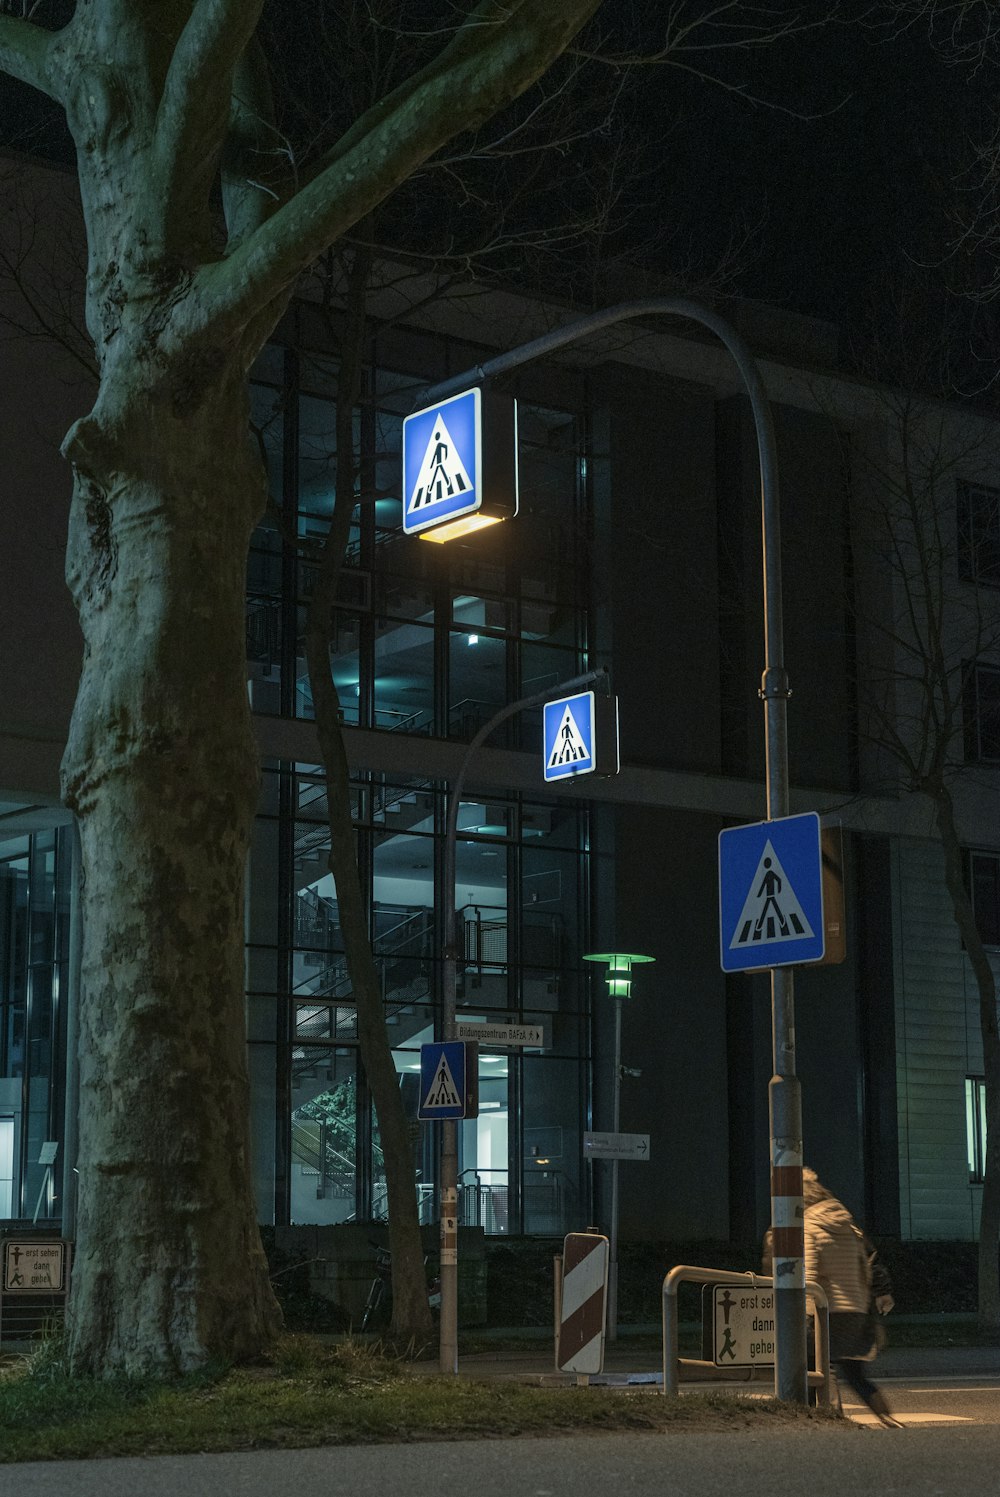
[403,386,482,534]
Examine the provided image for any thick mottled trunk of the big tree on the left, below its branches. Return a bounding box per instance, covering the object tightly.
[63,368,280,1374]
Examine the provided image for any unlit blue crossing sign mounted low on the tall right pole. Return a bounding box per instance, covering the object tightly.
[719,811,825,972]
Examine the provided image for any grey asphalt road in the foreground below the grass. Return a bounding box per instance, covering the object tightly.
[0,1424,997,1497]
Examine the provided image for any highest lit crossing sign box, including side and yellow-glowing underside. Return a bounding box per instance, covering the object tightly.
[403,386,516,540]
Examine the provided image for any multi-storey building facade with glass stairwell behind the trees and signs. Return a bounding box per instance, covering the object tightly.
[0,157,1000,1243]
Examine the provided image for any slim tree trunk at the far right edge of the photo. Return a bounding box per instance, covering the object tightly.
[933,783,1000,1331]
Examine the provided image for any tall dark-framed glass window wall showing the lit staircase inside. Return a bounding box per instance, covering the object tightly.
[247,342,598,1234]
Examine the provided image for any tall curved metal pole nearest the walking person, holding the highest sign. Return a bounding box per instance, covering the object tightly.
[421,296,807,1403]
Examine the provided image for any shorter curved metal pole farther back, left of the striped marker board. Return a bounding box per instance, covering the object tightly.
[439,666,608,1376]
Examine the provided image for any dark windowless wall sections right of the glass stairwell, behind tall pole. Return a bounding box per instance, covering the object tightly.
[594,365,865,1241]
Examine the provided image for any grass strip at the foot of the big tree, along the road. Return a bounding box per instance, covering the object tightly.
[0,1337,843,1461]
